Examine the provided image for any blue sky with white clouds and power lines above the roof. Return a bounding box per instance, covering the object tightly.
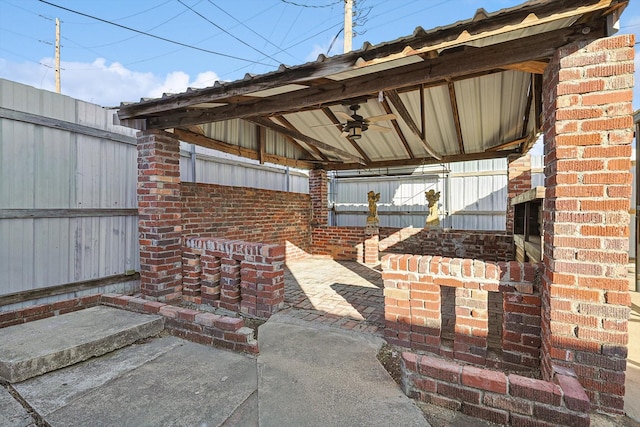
[0,0,640,108]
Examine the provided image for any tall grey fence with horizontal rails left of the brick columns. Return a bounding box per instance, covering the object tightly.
[0,80,139,303]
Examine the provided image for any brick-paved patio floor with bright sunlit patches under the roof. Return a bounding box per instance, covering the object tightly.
[284,258,384,335]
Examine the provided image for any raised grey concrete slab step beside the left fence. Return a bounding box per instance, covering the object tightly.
[0,306,164,383]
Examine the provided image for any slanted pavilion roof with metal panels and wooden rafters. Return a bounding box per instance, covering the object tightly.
[118,0,628,170]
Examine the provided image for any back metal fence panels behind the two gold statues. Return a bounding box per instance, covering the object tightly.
[330,156,544,230]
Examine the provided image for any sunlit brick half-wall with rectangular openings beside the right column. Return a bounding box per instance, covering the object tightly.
[382,254,541,371]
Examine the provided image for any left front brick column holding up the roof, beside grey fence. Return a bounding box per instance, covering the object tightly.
[138,131,182,301]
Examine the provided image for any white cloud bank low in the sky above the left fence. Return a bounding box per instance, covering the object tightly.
[0,58,218,107]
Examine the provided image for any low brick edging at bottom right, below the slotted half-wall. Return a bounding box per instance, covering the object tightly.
[401,352,591,427]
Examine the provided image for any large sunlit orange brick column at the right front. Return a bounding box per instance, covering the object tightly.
[541,35,634,413]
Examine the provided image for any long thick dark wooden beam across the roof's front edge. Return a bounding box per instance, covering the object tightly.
[136,22,604,129]
